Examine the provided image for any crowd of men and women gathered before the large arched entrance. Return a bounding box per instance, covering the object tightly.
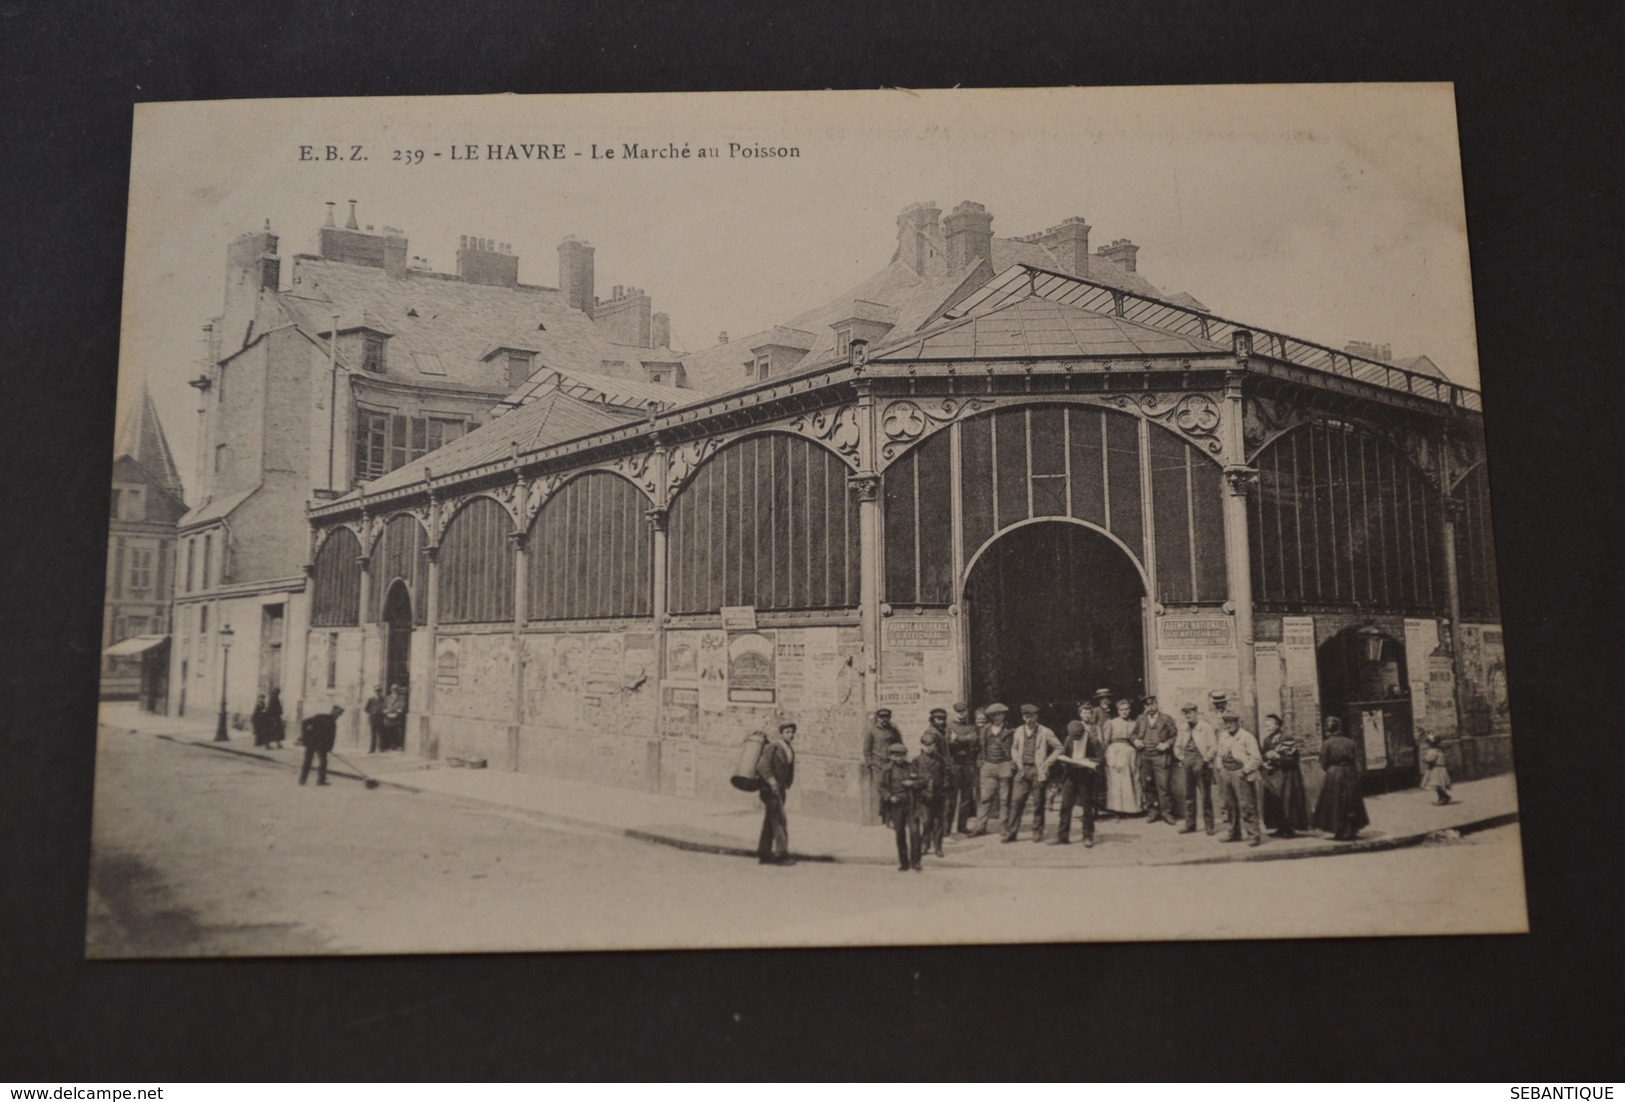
[863,689,1384,871]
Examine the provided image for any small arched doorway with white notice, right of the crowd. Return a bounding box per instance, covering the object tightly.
[1316,624,1417,792]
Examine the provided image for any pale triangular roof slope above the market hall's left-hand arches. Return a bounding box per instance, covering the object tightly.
[346,388,644,497]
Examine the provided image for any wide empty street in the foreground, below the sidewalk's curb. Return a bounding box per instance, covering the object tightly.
[86,728,1526,957]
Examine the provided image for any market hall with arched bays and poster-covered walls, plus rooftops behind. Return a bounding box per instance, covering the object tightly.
[302,203,1511,819]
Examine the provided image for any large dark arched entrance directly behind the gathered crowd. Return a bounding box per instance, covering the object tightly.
[964,520,1146,733]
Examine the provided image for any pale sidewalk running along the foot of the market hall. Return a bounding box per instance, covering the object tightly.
[101,705,1518,868]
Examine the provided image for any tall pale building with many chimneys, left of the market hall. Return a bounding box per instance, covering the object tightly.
[171,202,687,737]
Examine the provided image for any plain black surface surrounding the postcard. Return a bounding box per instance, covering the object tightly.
[0,0,1625,1082]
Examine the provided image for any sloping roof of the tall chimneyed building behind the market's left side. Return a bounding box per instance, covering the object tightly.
[276,254,678,390]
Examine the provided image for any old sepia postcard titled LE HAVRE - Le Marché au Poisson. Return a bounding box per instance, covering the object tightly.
[86,85,1528,957]
